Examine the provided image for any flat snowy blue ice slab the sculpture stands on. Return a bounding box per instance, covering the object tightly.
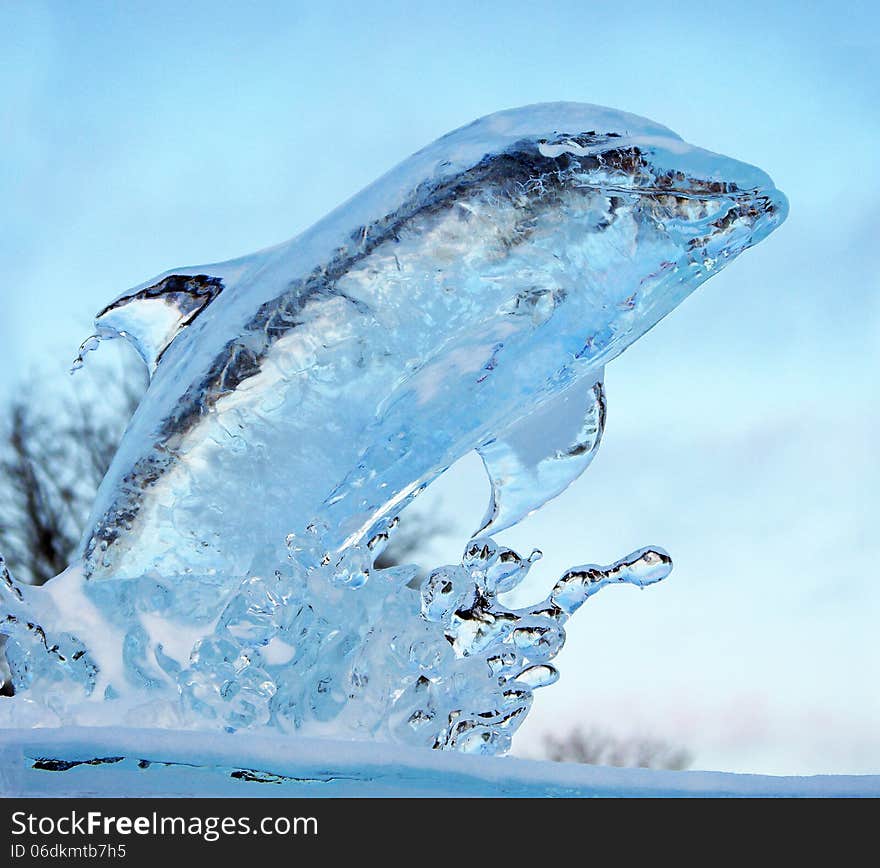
[0,728,880,797]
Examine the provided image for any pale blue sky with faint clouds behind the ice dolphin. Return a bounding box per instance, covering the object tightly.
[0,2,880,772]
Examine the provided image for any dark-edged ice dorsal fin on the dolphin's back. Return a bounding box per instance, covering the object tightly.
[95,274,223,376]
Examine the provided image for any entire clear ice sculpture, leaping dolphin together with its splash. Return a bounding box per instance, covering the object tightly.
[0,103,787,753]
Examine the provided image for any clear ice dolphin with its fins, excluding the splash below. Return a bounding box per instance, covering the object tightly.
[75,103,787,580]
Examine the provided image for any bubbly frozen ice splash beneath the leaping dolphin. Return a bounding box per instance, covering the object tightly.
[0,537,671,753]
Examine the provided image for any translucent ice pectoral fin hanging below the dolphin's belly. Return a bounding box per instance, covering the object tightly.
[475,375,605,535]
